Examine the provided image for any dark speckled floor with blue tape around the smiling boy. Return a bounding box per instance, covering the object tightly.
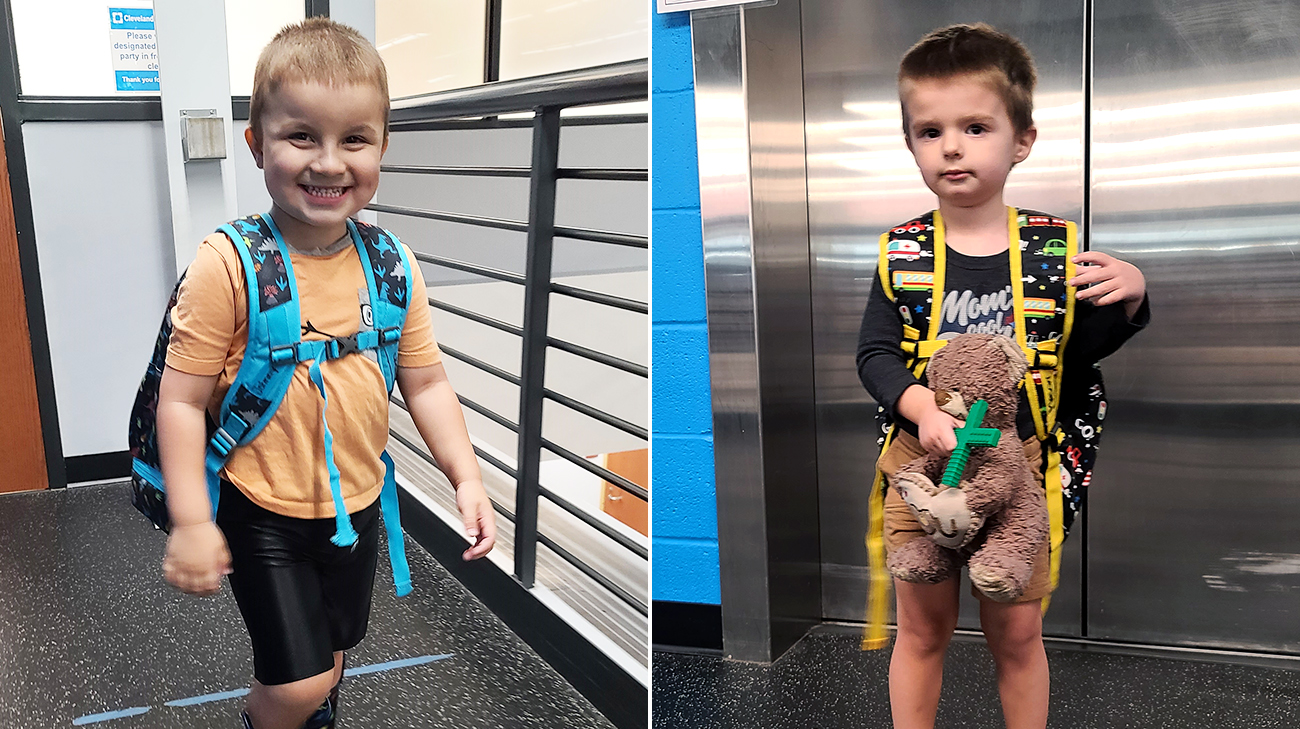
[0,485,612,729]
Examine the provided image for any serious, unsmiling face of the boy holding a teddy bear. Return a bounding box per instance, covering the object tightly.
[900,75,1037,208]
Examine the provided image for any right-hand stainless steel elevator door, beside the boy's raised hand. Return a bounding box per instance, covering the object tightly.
[1087,0,1300,652]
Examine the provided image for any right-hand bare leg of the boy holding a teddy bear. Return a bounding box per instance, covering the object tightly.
[979,595,1050,729]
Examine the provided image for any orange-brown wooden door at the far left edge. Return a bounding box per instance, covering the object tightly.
[0,124,49,491]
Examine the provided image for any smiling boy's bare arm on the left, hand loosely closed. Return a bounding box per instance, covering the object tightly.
[157,366,230,595]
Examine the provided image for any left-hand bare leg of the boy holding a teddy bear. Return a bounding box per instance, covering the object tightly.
[889,580,961,729]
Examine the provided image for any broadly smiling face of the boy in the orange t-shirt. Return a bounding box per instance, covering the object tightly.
[244,82,387,248]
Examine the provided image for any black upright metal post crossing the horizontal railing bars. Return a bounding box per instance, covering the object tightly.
[515,108,560,587]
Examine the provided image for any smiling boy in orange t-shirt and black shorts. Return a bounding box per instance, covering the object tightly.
[157,18,495,729]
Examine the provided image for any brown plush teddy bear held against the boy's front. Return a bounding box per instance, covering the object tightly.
[889,334,1048,602]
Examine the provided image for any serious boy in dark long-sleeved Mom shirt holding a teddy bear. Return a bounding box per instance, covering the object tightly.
[857,23,1149,729]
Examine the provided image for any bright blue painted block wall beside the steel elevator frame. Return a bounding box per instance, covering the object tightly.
[647,0,722,604]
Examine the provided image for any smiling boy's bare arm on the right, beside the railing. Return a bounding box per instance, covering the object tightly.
[398,363,497,560]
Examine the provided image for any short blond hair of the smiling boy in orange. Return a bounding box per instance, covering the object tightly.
[248,18,389,140]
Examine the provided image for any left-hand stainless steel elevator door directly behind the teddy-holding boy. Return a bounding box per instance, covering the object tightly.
[803,0,1084,635]
